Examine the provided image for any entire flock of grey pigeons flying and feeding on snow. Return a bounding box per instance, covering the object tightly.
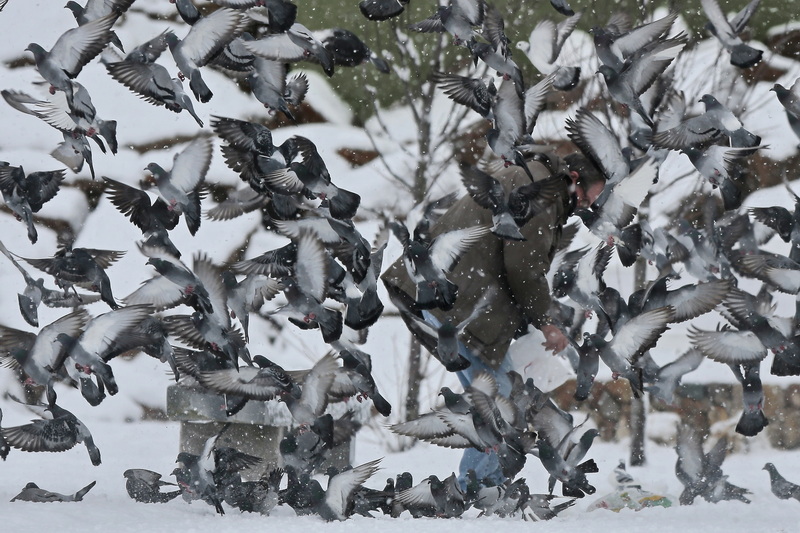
[0,0,800,520]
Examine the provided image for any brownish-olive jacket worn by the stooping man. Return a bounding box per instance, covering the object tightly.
[382,156,570,368]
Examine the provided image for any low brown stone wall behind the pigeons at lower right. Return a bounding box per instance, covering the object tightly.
[551,380,800,449]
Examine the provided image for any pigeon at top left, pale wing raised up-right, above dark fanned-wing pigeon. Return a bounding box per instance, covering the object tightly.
[165,8,246,103]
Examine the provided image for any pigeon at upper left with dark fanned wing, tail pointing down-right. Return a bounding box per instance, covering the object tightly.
[103,32,203,128]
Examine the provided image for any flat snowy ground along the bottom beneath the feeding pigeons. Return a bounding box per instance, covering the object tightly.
[0,421,800,533]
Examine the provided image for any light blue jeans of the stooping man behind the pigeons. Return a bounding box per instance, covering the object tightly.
[422,311,513,490]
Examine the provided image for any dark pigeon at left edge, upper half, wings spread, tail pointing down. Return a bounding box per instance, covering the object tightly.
[0,165,64,244]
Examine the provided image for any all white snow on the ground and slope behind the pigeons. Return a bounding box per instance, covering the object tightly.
[0,0,800,533]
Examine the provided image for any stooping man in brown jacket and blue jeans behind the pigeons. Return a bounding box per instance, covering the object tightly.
[382,154,605,485]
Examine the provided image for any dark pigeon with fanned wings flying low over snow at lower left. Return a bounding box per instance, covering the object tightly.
[2,385,100,466]
